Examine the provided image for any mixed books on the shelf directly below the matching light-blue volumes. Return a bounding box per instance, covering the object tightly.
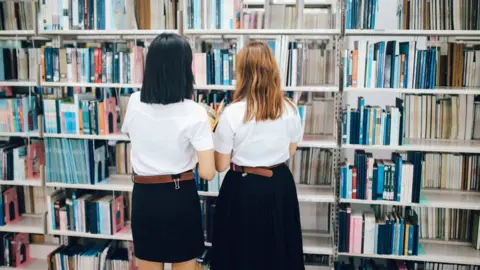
[48,190,126,235]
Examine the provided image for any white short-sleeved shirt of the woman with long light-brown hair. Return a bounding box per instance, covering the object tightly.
[214,101,303,167]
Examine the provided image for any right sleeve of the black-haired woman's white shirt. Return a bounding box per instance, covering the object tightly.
[190,112,213,151]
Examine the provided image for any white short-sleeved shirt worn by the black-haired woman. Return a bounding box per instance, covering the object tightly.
[122,92,213,175]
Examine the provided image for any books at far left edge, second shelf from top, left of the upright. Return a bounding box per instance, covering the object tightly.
[0,47,40,81]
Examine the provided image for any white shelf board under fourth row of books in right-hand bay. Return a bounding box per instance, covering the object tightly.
[340,189,480,210]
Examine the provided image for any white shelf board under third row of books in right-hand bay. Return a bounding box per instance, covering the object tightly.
[342,139,480,153]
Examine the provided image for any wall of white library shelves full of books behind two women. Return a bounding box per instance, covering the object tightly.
[0,0,480,270]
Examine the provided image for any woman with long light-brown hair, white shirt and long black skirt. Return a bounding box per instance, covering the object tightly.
[212,42,305,270]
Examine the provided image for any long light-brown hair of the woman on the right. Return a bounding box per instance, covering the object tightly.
[234,42,285,122]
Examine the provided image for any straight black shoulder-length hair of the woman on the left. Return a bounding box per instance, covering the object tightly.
[140,33,194,105]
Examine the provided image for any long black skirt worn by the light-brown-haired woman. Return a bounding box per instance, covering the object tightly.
[211,165,305,270]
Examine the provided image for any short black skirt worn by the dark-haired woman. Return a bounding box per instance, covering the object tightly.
[132,180,205,263]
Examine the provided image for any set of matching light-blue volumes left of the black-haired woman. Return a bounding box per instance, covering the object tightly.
[44,138,108,185]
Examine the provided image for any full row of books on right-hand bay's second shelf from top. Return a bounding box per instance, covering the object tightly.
[343,40,480,89]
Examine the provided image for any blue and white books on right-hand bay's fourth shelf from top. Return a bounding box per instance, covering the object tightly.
[340,150,423,203]
